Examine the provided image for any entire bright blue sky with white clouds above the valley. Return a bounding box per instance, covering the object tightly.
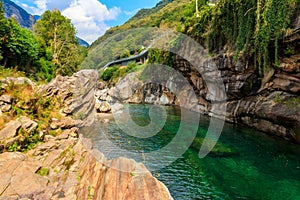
[12,0,160,43]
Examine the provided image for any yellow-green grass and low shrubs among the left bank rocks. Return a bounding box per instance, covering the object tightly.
[0,75,62,152]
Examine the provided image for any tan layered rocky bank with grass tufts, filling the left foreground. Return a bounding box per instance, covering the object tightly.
[0,71,172,200]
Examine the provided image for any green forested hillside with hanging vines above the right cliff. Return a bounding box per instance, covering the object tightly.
[89,0,300,80]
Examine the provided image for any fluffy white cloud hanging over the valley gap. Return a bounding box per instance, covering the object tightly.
[16,0,121,43]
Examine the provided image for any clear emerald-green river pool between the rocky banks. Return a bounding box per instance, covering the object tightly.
[83,105,300,200]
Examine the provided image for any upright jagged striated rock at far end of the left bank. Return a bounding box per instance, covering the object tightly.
[39,70,98,125]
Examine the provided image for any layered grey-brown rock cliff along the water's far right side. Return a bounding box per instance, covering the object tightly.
[96,51,300,143]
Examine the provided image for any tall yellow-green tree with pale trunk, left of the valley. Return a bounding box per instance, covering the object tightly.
[34,10,85,75]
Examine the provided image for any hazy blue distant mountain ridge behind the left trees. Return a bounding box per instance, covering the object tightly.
[0,0,89,47]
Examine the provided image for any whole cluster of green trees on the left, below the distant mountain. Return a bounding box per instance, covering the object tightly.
[0,2,86,81]
